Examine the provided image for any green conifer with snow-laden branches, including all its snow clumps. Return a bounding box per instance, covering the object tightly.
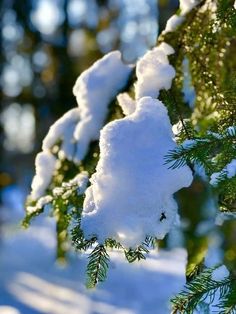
[23,0,236,313]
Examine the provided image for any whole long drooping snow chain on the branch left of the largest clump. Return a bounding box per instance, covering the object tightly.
[29,51,132,201]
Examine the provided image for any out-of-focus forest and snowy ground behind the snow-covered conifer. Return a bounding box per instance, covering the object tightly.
[0,0,233,314]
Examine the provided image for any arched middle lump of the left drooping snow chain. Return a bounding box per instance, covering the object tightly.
[42,108,80,160]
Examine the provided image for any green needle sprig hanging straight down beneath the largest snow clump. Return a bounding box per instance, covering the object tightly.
[86,244,110,288]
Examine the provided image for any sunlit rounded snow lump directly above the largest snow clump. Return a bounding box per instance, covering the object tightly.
[135,43,175,99]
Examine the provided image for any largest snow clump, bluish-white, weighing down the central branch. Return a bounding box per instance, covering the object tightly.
[81,97,192,247]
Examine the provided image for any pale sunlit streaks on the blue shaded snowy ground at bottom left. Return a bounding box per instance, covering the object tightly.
[9,273,134,314]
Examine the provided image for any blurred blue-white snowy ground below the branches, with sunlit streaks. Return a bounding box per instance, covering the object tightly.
[0,186,186,314]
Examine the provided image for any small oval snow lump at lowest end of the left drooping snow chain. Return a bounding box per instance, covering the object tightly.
[31,151,56,200]
